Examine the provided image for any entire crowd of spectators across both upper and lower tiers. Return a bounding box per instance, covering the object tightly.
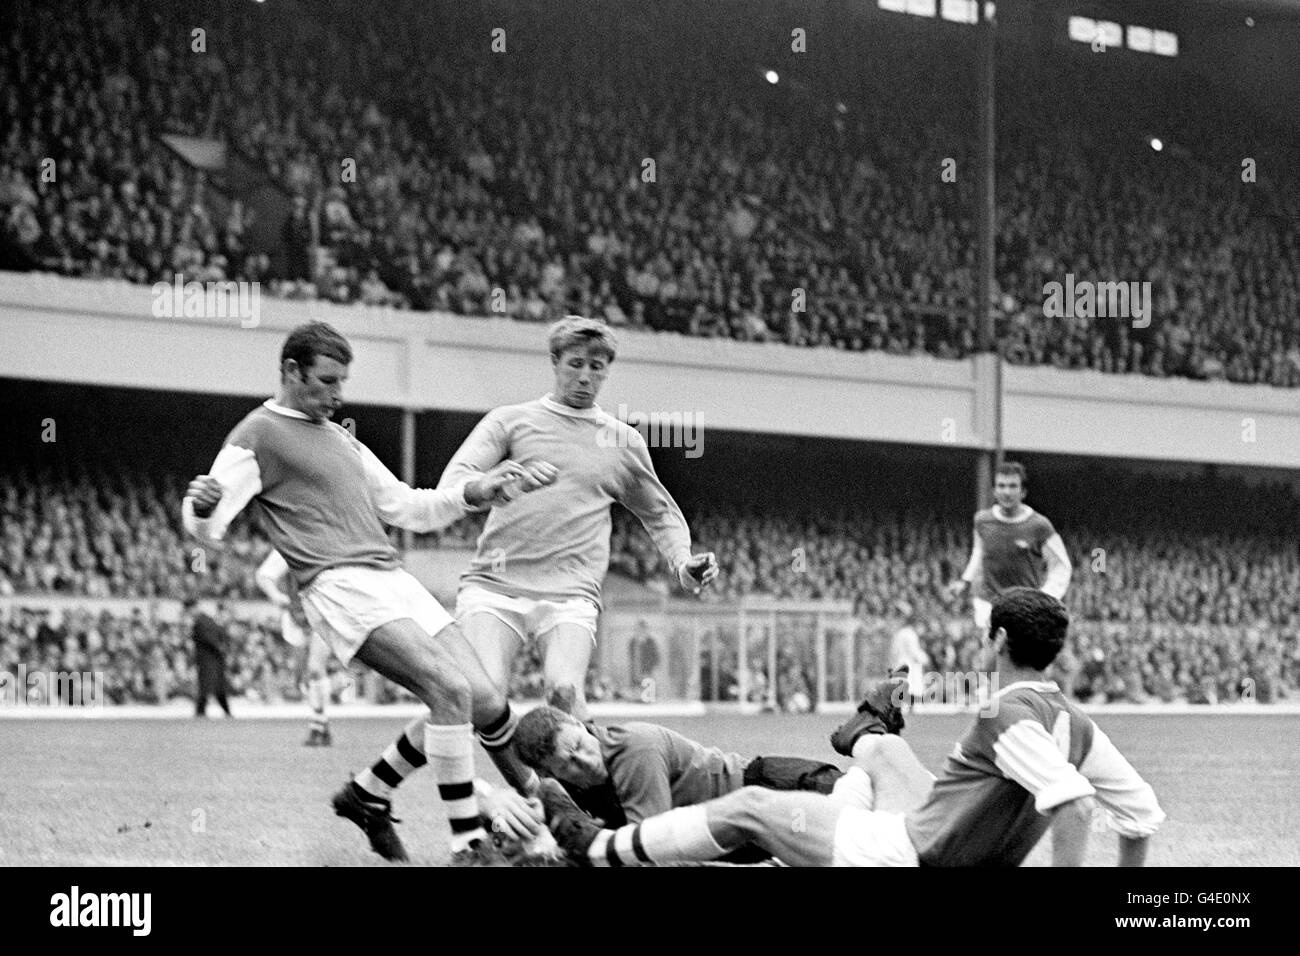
[0,0,1300,701]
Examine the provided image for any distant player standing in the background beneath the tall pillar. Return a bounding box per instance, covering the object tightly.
[948,462,1073,632]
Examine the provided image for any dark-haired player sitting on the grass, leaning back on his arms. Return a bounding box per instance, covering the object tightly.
[542,588,1165,866]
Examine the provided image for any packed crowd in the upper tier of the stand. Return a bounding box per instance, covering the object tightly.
[0,0,1300,386]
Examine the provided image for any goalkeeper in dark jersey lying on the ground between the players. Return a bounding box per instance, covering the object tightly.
[481,676,906,866]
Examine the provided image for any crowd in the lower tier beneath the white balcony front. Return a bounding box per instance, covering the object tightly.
[0,460,1300,702]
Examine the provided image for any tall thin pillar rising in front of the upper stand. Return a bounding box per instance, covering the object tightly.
[975,0,1002,509]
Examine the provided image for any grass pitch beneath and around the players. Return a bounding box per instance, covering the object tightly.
[0,714,1300,866]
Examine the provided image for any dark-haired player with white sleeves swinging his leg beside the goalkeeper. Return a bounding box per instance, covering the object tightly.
[182,323,555,865]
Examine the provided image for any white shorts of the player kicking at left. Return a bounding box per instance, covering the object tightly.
[302,564,454,665]
